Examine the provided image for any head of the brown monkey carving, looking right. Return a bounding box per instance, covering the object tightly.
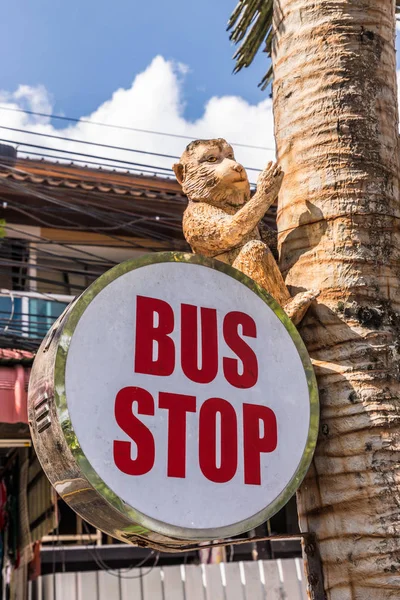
[173,138,250,208]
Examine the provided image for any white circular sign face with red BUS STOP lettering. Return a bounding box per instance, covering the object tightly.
[65,262,316,530]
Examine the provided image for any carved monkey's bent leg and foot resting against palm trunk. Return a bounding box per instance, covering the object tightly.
[232,240,319,325]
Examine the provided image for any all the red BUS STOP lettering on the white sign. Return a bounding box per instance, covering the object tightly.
[113,296,278,485]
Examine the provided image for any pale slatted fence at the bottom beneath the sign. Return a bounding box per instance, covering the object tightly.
[30,558,307,600]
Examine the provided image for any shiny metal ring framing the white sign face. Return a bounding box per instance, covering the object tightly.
[54,252,319,540]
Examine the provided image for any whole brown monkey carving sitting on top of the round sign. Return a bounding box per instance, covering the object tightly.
[173,138,318,324]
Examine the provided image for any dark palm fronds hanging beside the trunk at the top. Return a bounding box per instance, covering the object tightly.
[227,0,400,90]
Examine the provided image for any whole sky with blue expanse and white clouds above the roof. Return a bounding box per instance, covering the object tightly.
[0,0,398,182]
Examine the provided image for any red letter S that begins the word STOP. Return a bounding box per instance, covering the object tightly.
[113,387,155,475]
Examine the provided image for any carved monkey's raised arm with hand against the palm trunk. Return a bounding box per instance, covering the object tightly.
[183,165,283,256]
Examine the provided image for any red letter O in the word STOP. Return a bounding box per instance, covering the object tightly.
[199,398,238,483]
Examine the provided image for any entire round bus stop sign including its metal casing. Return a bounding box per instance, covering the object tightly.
[30,253,318,543]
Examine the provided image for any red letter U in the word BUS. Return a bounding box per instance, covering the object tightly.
[181,304,218,383]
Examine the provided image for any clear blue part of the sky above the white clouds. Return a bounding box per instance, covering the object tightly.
[0,0,267,120]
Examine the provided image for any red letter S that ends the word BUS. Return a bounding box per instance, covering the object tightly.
[223,311,258,389]
